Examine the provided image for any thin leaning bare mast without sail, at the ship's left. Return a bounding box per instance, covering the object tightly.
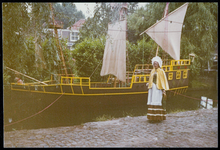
[50,3,68,76]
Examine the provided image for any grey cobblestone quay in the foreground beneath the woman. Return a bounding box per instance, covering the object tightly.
[4,108,218,147]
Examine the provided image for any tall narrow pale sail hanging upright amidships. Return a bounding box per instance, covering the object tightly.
[100,20,126,82]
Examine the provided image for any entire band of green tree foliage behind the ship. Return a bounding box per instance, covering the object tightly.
[2,3,218,85]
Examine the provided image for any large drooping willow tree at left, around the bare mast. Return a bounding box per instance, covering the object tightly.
[2,3,78,83]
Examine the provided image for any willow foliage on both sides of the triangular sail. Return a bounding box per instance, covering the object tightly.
[128,3,218,77]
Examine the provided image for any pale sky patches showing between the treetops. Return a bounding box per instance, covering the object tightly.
[74,3,146,18]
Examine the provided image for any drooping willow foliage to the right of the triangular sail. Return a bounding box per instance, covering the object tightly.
[181,3,218,76]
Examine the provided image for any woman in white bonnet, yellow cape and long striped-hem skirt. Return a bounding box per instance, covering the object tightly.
[147,56,169,120]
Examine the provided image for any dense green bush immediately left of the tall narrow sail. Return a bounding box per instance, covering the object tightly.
[73,36,105,81]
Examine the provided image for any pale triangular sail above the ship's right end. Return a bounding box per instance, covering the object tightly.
[140,3,188,60]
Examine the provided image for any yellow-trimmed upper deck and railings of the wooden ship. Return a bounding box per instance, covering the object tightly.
[11,59,190,94]
